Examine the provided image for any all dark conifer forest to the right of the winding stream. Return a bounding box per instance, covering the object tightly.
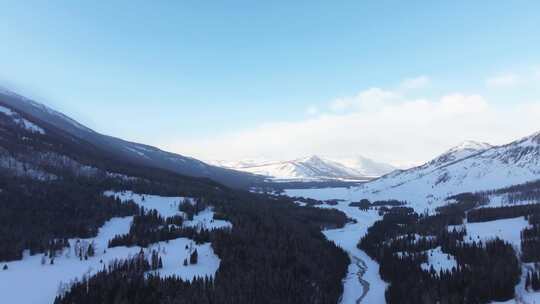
[352,188,540,303]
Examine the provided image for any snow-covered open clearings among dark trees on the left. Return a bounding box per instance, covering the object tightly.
[0,191,232,304]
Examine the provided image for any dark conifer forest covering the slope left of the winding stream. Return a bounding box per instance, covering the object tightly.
[0,166,349,303]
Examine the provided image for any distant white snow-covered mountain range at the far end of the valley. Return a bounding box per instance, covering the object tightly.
[212,155,394,181]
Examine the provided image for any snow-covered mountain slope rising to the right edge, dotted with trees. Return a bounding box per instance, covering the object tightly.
[354,133,540,209]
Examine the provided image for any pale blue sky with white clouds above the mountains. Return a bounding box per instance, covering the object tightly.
[0,0,540,166]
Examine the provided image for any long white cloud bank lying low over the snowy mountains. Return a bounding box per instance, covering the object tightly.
[166,88,540,164]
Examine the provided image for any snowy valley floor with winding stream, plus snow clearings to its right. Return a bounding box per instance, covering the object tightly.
[285,188,540,304]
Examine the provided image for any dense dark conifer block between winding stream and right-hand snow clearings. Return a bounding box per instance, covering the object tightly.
[359,207,521,304]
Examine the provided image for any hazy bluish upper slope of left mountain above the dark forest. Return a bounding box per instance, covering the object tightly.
[0,90,264,188]
